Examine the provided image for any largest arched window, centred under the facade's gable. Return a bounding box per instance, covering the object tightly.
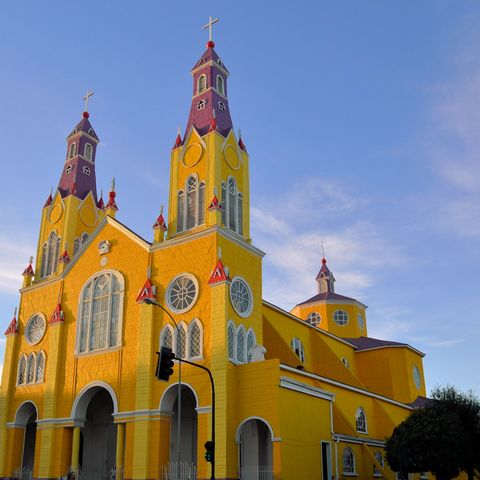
[77,272,124,353]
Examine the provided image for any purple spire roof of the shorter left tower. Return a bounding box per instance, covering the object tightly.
[58,112,100,203]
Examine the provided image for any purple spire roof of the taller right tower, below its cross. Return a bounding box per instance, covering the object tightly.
[185,41,233,137]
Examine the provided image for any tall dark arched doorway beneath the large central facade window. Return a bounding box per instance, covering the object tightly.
[73,385,117,480]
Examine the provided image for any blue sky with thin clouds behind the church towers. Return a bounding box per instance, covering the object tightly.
[0,0,480,393]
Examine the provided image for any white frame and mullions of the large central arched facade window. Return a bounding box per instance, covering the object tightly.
[75,269,125,356]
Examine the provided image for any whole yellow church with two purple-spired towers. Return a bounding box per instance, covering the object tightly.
[0,25,430,480]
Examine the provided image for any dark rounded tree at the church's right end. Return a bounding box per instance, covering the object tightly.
[386,387,480,480]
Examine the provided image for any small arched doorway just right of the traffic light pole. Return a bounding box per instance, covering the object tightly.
[237,418,273,480]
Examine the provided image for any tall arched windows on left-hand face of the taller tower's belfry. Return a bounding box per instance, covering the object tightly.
[177,175,206,232]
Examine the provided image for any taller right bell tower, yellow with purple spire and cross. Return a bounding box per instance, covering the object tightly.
[167,27,250,241]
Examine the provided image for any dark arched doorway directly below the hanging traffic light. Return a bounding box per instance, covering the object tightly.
[160,384,198,478]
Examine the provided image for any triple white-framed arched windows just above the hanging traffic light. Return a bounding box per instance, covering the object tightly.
[160,318,203,360]
